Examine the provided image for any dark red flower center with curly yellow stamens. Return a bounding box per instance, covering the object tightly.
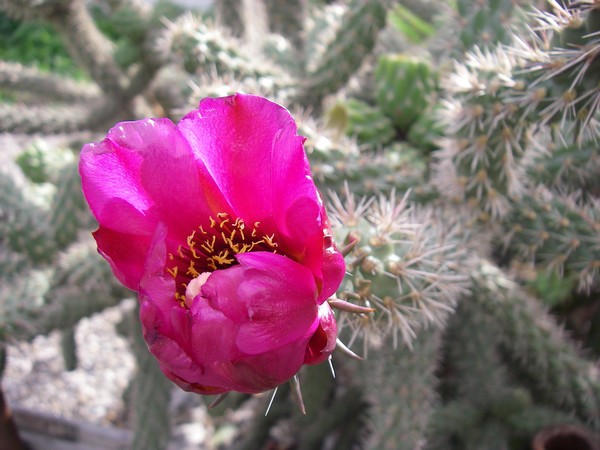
[166,212,278,306]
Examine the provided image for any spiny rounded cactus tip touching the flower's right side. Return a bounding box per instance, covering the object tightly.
[331,192,466,351]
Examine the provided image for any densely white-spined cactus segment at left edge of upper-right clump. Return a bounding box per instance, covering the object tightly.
[433,49,528,220]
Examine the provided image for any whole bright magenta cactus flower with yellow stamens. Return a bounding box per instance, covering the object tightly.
[80,94,345,394]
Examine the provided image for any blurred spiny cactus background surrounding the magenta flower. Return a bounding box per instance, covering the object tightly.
[0,0,600,450]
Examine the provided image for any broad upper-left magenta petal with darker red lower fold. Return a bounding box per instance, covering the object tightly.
[79,119,228,290]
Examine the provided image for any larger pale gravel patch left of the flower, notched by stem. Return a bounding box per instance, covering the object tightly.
[2,302,135,426]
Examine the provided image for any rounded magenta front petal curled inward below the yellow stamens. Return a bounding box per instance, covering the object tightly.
[202,252,317,355]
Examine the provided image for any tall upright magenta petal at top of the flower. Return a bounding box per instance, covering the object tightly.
[179,94,321,244]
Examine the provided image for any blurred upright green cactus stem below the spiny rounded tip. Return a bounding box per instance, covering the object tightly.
[361,330,441,450]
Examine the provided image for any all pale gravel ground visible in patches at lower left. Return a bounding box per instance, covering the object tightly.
[2,300,258,450]
